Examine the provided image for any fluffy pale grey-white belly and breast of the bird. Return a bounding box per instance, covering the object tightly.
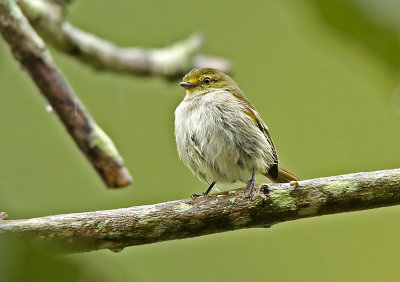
[175,93,272,183]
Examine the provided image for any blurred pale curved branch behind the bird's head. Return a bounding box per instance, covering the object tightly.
[18,0,231,77]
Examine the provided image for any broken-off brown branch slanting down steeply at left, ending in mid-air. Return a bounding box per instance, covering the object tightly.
[0,0,132,188]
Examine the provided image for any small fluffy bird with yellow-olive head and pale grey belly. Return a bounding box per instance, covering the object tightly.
[175,68,299,198]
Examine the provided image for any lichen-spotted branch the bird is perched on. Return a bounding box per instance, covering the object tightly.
[0,169,400,252]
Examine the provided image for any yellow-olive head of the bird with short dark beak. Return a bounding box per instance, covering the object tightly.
[179,68,238,99]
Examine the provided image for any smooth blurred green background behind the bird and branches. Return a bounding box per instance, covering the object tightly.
[0,0,400,281]
